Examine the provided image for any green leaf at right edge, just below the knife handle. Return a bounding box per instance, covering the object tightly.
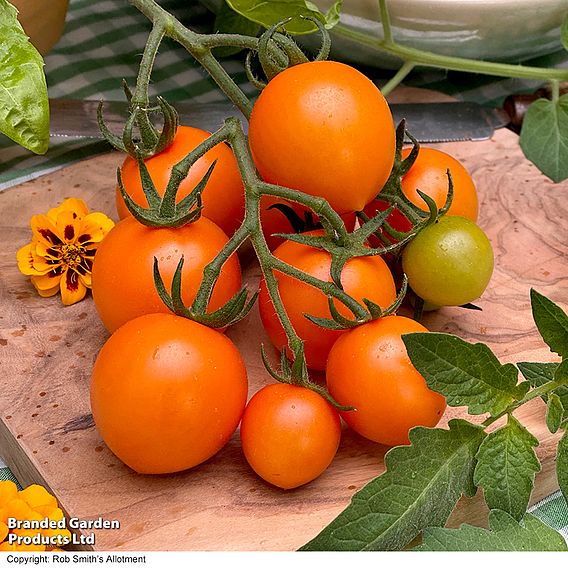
[519,95,568,182]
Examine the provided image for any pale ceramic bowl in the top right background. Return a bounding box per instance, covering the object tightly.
[202,0,568,67]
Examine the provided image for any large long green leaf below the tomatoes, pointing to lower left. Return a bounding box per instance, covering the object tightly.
[301,420,485,550]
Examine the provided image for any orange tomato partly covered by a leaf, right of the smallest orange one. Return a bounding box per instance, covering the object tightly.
[326,316,446,446]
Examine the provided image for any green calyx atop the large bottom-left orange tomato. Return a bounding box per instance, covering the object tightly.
[154,256,258,329]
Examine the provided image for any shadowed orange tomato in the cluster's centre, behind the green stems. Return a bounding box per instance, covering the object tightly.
[258,232,396,370]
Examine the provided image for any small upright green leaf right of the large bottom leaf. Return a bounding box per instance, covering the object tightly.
[473,415,540,520]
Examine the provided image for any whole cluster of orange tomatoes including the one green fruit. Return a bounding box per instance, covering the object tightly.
[87,61,493,488]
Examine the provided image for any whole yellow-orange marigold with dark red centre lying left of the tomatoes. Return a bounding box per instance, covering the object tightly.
[17,198,114,305]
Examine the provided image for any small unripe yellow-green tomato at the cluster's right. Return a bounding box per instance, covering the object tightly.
[402,216,493,306]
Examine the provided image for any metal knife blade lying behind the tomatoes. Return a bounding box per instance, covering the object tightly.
[49,99,510,143]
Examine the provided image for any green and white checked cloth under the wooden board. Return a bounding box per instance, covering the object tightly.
[0,0,568,552]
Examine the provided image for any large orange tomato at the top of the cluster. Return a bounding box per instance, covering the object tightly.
[249,61,395,213]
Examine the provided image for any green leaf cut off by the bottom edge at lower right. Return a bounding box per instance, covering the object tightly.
[413,510,568,552]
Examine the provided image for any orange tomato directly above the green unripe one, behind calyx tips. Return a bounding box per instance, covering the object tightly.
[402,147,478,222]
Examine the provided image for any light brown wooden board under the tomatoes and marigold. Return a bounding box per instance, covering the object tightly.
[0,124,568,550]
